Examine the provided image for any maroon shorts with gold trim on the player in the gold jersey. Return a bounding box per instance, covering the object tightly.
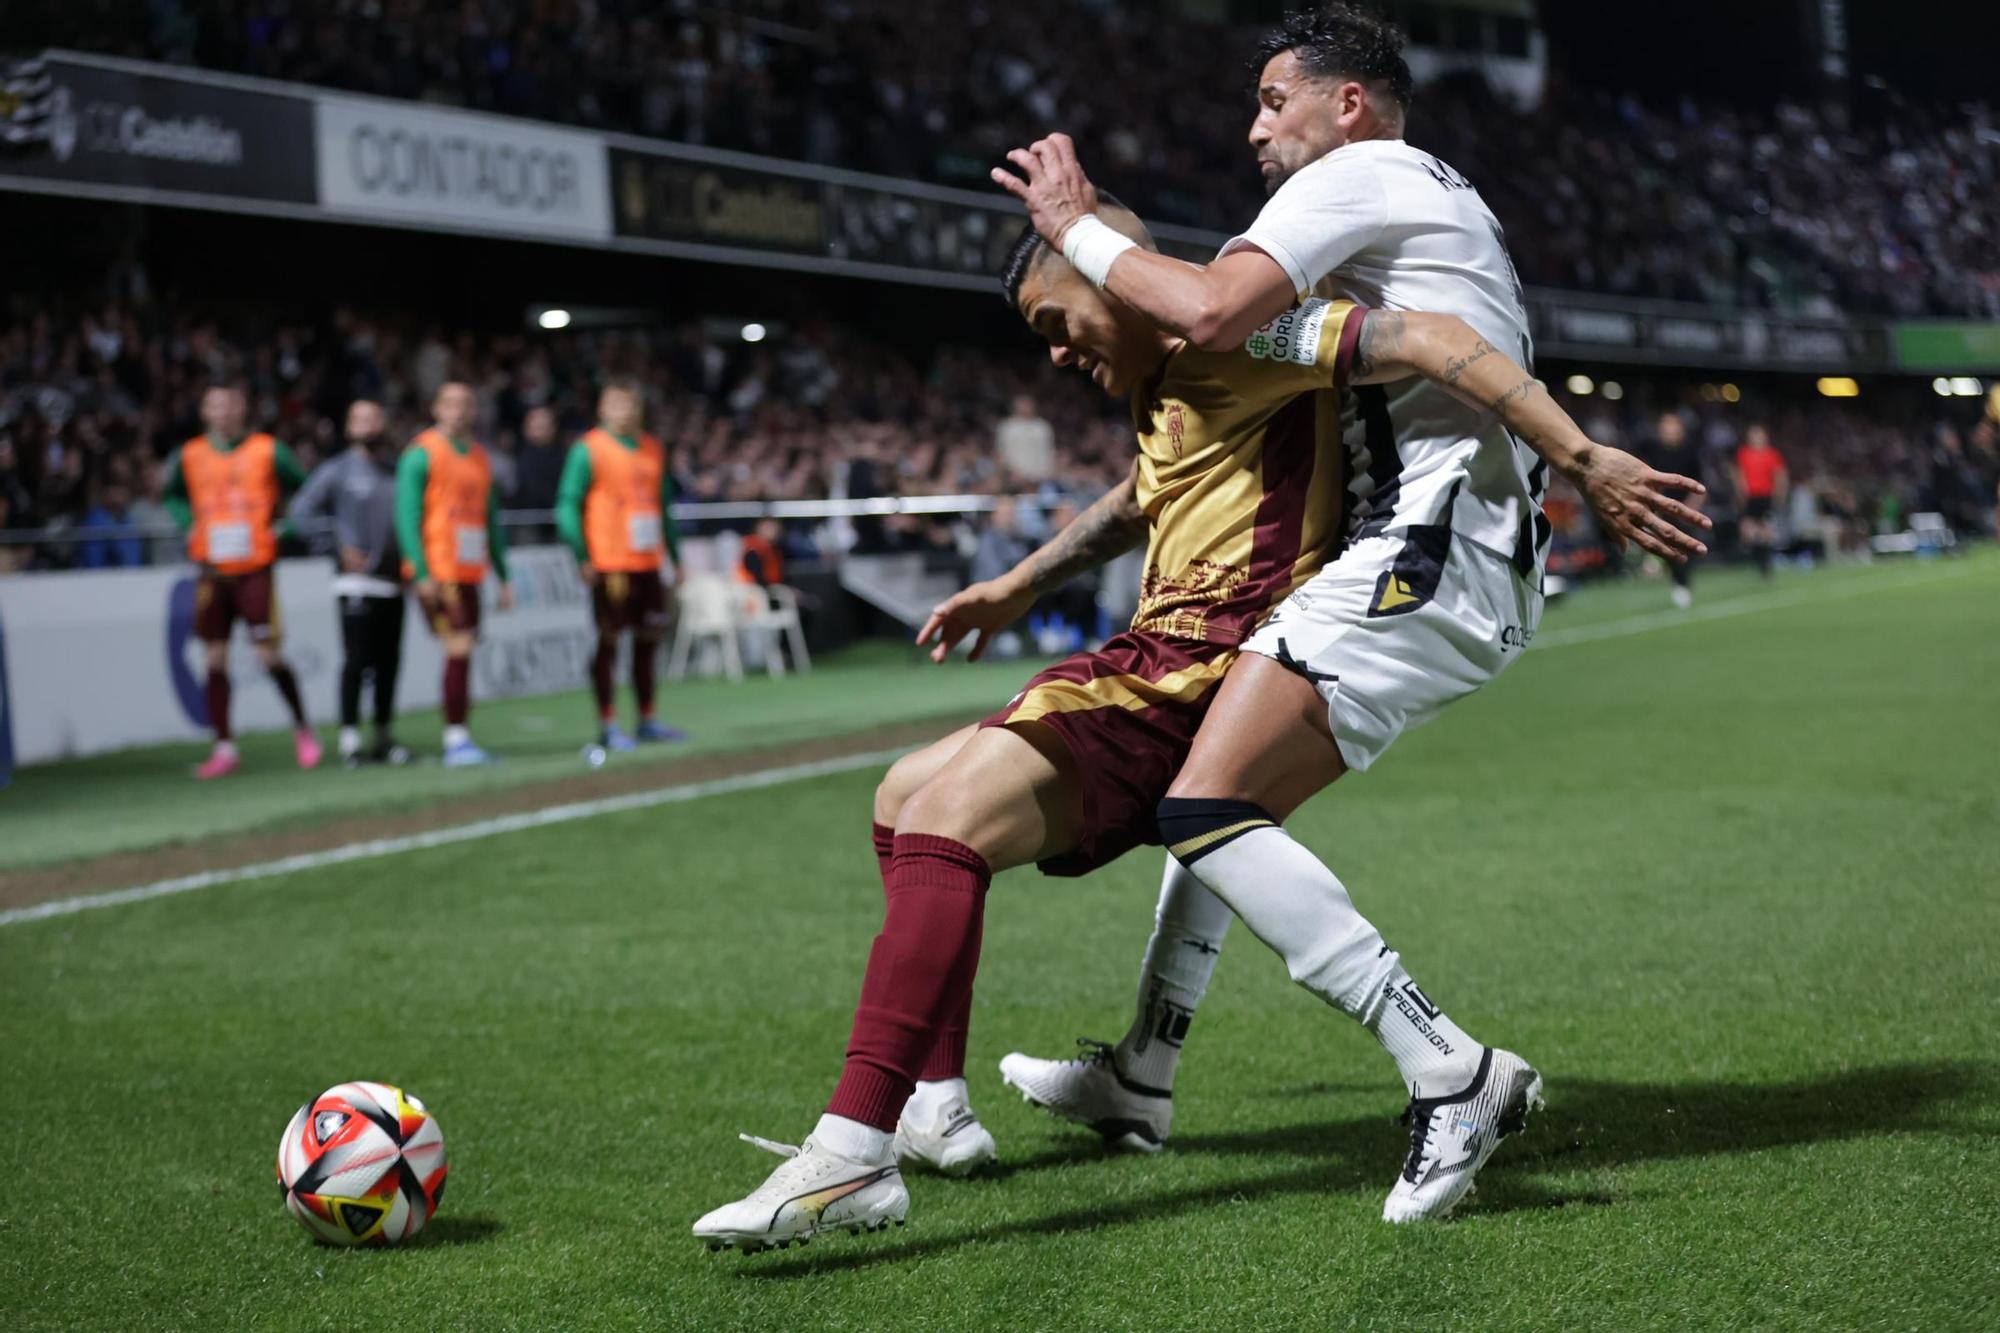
[980,630,1236,875]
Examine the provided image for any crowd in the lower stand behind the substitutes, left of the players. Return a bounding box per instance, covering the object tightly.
[0,294,1130,568]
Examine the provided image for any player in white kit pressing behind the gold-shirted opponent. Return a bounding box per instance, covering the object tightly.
[992,4,1708,1223]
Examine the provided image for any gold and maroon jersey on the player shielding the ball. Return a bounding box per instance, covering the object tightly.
[1132,300,1366,644]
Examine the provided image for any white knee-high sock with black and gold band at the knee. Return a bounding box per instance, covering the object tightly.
[1160,801,1480,1095]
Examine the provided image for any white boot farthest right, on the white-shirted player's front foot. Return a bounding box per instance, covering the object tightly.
[1382,1047,1542,1223]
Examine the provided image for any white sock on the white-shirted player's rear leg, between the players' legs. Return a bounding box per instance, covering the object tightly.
[1118,857,1230,1091]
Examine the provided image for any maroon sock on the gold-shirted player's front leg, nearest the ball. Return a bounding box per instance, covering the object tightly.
[826,833,992,1133]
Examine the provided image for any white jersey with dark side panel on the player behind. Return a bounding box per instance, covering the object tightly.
[1222,140,1548,576]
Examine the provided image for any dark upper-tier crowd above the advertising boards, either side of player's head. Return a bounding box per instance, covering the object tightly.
[35,0,2000,318]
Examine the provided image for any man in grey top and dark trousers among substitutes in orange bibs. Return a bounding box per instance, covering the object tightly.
[292,398,410,769]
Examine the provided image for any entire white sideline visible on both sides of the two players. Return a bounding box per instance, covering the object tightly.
[0,564,1984,927]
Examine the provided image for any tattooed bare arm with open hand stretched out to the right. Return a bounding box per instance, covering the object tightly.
[1348,310,1710,560]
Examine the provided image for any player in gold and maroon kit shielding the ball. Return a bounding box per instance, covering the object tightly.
[694,200,1624,1249]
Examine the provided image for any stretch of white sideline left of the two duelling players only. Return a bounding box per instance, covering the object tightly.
[0,747,912,927]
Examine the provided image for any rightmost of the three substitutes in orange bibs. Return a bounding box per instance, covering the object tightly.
[556,378,688,751]
